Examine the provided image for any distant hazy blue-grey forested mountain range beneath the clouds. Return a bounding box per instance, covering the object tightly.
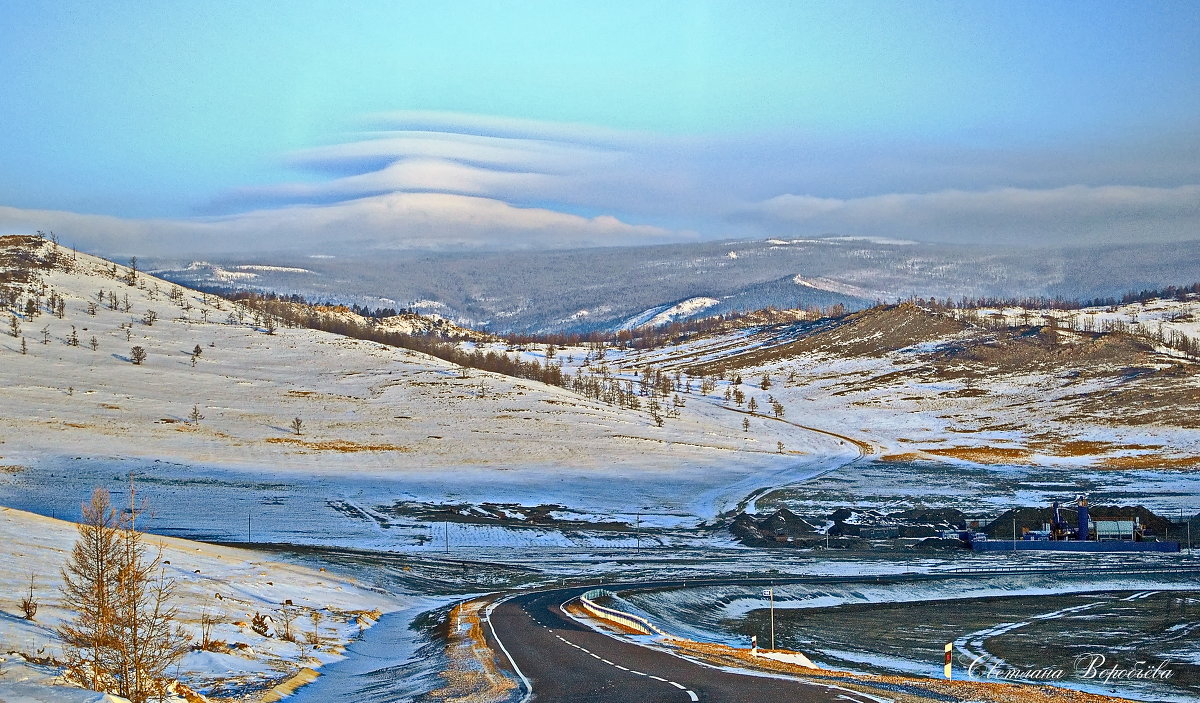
[144,236,1200,332]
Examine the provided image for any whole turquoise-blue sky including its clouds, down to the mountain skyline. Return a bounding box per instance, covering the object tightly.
[0,1,1200,248]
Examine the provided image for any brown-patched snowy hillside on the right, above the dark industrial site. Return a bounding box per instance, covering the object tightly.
[559,301,1200,515]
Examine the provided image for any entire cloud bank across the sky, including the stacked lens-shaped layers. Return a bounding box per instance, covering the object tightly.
[0,112,1200,253]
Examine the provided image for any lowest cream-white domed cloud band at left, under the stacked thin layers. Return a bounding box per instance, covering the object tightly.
[0,193,695,256]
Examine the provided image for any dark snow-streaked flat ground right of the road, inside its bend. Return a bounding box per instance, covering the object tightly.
[617,573,1200,701]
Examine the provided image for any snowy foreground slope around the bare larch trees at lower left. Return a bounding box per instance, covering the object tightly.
[0,497,398,703]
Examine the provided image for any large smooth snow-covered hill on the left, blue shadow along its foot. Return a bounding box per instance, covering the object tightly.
[0,239,852,547]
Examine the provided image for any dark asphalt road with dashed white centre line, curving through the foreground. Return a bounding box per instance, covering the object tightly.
[488,588,868,703]
